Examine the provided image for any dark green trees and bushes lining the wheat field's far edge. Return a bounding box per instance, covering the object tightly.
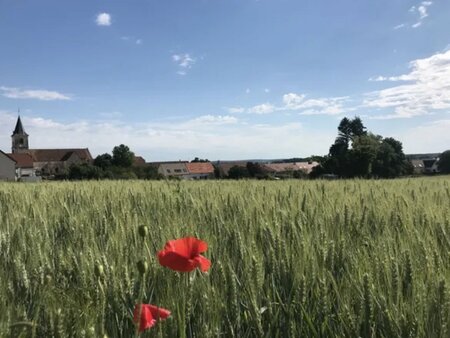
[64,117,450,180]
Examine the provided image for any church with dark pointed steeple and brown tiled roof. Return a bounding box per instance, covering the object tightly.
[9,116,93,179]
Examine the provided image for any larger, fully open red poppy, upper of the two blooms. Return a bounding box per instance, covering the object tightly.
[158,237,211,272]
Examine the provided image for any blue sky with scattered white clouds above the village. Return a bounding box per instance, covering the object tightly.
[0,0,450,161]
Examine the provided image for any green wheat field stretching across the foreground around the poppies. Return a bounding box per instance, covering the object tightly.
[0,176,450,337]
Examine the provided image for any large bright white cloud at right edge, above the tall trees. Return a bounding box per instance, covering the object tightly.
[363,51,450,119]
